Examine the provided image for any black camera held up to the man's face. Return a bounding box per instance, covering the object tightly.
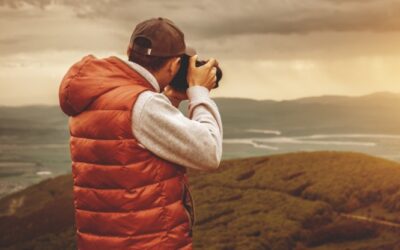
[170,55,222,91]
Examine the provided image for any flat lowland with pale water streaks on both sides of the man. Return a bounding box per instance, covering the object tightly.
[0,132,400,197]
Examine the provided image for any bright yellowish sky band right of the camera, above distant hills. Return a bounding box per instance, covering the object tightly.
[212,56,400,100]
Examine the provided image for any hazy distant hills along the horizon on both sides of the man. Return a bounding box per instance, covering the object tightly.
[0,92,400,140]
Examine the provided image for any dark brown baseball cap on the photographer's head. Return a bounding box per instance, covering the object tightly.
[129,17,196,57]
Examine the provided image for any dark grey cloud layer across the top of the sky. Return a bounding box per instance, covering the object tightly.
[0,0,400,54]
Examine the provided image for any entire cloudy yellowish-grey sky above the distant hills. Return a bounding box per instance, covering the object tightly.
[0,0,400,105]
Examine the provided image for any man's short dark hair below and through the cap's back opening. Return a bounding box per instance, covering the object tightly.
[129,37,173,72]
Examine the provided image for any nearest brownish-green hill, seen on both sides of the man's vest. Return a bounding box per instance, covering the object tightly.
[0,151,400,250]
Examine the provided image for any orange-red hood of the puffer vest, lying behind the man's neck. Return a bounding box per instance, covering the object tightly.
[59,55,156,116]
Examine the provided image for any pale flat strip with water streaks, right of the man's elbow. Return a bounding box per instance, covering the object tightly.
[223,129,400,162]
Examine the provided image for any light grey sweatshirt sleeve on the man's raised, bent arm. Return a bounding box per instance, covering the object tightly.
[132,86,223,170]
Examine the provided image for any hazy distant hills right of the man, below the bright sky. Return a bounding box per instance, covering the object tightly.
[181,92,400,138]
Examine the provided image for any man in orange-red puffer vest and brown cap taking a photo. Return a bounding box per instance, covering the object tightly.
[59,17,223,250]
